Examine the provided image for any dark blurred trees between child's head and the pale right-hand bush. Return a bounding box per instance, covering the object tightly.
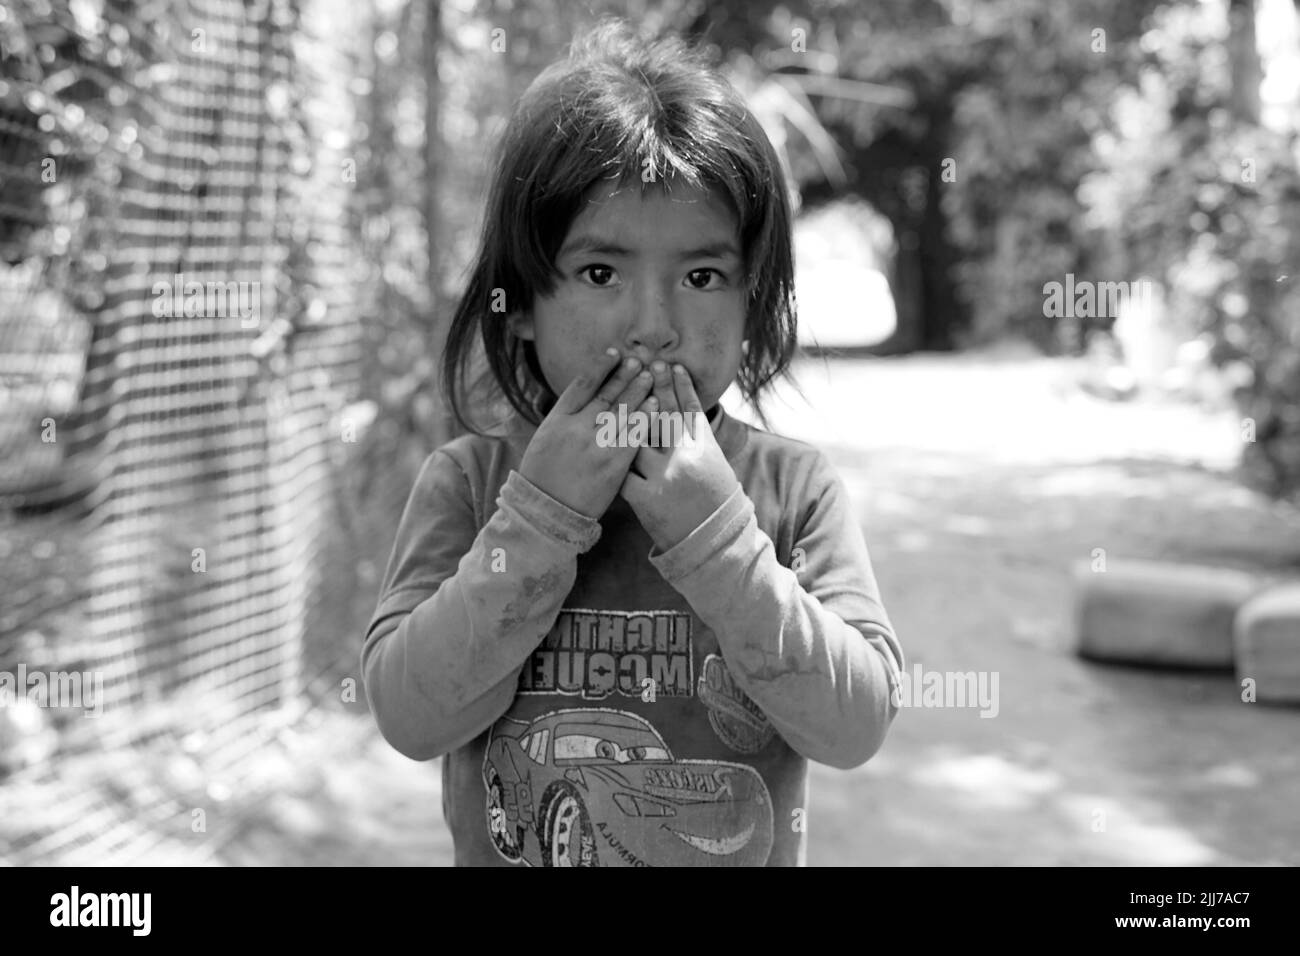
[692,0,1156,352]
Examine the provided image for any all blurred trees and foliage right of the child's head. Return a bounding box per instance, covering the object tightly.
[686,0,1300,502]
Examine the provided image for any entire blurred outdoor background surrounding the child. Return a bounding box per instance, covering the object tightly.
[0,0,1300,865]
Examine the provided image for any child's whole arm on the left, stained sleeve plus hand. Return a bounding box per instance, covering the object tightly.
[361,349,660,760]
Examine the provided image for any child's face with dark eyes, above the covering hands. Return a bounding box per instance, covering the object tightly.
[511,183,746,410]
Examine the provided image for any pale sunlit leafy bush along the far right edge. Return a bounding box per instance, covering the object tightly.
[1096,3,1300,496]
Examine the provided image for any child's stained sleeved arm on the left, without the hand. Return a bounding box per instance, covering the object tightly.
[361,451,601,760]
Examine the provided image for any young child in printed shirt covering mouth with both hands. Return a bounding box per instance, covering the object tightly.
[361,16,902,866]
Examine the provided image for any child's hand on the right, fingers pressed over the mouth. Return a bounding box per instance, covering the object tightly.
[621,365,740,551]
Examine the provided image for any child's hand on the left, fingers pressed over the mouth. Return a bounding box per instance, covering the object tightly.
[519,349,654,518]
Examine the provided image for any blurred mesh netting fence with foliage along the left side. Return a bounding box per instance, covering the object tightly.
[0,0,361,864]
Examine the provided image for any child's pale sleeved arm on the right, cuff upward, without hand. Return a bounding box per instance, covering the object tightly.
[651,458,904,769]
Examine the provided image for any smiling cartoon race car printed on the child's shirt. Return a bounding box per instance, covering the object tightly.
[484,708,772,866]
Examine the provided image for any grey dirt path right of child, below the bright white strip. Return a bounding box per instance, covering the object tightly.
[810,455,1300,865]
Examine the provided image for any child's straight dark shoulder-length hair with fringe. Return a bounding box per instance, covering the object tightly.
[442,21,797,432]
